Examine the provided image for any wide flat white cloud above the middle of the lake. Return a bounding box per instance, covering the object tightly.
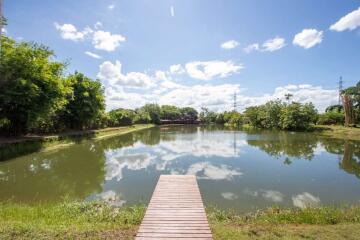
[185,60,243,80]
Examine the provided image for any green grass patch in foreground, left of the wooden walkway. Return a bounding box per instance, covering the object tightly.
[0,202,145,239]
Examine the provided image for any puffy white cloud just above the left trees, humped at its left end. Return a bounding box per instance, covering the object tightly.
[97,61,151,87]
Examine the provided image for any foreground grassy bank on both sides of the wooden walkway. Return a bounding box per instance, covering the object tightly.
[0,203,360,239]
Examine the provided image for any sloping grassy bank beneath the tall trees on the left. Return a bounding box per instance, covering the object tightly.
[0,124,154,161]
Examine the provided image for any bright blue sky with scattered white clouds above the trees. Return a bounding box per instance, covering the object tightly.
[4,0,360,111]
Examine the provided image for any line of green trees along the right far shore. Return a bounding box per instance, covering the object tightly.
[199,82,360,130]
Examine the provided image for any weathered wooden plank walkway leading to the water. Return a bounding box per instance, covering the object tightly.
[135,175,212,240]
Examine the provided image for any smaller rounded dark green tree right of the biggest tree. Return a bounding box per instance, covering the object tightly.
[61,72,105,129]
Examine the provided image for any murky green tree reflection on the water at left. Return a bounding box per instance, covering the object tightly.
[0,129,160,202]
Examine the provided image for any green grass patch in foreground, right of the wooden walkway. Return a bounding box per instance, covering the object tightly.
[207,206,360,239]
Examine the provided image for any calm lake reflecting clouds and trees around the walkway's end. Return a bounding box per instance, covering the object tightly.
[0,126,360,212]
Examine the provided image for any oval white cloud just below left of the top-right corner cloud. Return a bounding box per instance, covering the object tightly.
[293,29,323,49]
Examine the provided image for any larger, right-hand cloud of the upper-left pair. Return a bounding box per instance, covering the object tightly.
[93,30,126,52]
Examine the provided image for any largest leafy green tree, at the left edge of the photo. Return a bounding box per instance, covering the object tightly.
[0,36,67,135]
